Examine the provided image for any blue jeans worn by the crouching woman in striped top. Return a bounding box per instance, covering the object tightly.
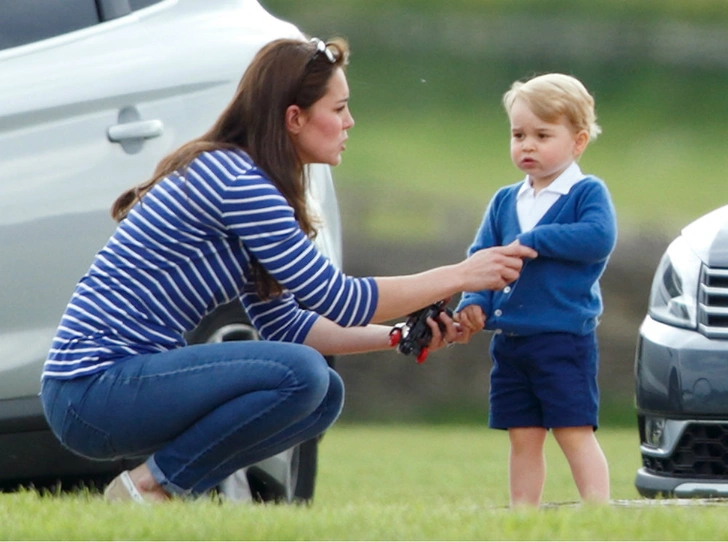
[41,341,344,495]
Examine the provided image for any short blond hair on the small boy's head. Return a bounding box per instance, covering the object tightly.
[503,73,602,141]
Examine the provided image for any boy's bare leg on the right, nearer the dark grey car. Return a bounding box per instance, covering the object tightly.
[554,426,609,504]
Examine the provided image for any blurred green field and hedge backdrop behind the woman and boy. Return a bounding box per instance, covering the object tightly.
[262,0,728,425]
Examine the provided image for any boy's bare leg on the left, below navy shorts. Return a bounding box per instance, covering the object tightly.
[508,427,547,507]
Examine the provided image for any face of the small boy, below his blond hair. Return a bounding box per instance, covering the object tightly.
[510,100,589,190]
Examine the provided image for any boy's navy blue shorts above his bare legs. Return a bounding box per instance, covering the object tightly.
[489,332,599,429]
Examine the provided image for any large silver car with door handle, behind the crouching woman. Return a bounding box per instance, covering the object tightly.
[0,0,341,501]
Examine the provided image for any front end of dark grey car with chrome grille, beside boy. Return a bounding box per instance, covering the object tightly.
[635,206,728,497]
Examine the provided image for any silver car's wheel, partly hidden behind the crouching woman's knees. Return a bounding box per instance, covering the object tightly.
[187,301,324,503]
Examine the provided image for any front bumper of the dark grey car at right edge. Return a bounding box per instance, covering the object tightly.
[635,316,728,498]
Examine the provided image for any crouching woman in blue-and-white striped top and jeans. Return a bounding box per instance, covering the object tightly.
[41,39,535,502]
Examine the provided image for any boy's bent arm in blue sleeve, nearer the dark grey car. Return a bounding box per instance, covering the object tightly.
[518,183,617,262]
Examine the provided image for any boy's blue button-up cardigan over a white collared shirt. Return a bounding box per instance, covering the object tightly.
[457,177,617,335]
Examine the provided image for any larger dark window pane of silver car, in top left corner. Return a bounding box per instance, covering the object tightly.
[0,0,99,49]
